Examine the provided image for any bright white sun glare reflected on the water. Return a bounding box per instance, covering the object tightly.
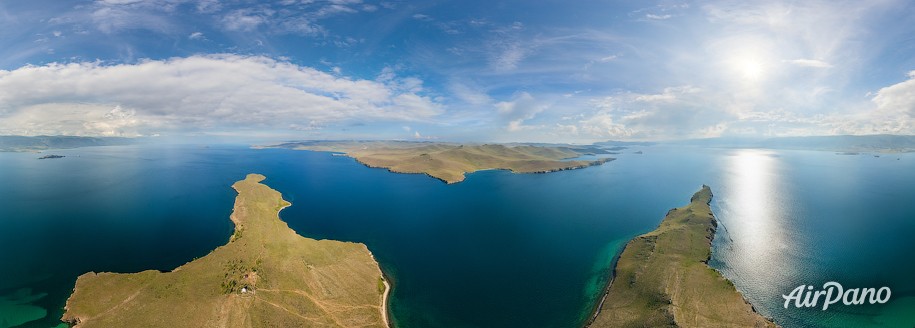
[712,149,797,314]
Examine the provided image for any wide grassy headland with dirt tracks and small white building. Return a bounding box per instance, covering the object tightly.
[63,174,385,328]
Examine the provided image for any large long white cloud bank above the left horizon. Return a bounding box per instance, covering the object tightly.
[0,54,443,136]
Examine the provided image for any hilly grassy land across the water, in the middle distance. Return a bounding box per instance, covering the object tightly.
[262,141,613,183]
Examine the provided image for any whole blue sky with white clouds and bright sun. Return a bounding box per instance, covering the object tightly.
[0,0,915,143]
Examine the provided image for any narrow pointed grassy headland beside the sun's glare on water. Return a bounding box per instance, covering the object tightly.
[591,186,775,327]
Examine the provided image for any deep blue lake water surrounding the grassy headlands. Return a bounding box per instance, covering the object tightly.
[0,146,915,328]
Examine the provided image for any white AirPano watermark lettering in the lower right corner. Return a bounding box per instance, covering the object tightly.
[782,281,891,311]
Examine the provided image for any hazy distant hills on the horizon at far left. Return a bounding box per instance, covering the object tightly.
[0,136,133,151]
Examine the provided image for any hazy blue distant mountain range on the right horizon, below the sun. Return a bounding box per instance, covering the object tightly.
[666,134,915,152]
